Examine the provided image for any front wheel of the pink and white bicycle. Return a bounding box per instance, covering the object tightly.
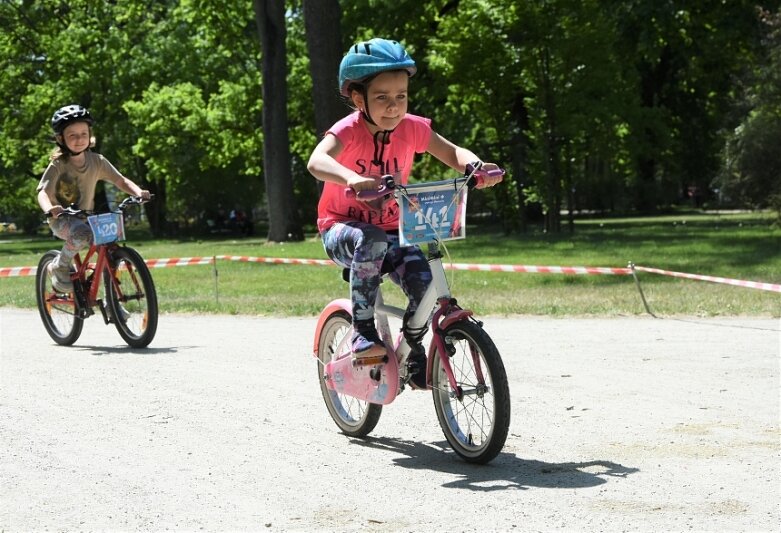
[432,321,510,464]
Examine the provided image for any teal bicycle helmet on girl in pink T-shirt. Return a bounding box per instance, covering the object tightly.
[339,38,418,97]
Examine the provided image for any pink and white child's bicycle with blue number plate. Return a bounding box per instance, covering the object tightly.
[314,164,510,464]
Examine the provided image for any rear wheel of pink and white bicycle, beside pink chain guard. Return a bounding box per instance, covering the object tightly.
[317,311,382,437]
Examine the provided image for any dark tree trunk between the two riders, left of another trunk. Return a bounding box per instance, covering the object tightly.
[253,0,304,242]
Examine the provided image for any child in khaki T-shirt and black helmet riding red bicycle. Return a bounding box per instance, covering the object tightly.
[36,104,150,293]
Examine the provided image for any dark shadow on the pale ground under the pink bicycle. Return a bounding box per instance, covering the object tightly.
[350,437,640,492]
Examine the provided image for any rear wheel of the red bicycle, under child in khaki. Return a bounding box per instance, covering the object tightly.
[35,250,84,346]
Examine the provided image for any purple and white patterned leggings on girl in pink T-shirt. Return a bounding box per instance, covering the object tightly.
[322,222,431,326]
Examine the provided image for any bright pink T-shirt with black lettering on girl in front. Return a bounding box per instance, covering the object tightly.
[317,111,431,233]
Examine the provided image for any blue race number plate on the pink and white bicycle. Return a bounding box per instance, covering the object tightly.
[399,180,467,246]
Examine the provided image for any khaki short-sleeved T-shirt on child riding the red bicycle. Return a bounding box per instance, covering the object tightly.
[36,152,124,211]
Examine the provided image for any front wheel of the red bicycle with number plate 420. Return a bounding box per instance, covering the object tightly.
[104,247,158,348]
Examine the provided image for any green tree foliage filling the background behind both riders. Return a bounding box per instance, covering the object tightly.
[0,0,781,238]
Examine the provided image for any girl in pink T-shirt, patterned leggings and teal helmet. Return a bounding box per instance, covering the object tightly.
[307,38,501,389]
